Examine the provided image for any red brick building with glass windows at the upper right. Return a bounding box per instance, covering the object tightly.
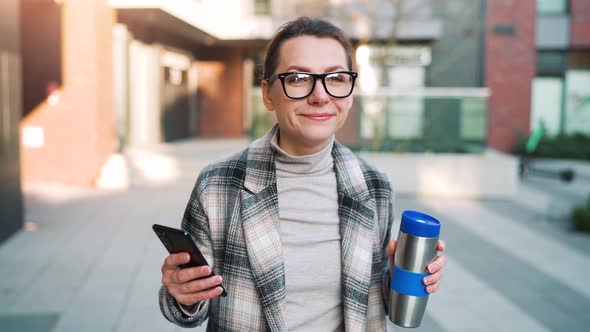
[485,0,590,152]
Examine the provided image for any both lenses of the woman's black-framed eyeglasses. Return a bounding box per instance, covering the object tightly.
[284,73,353,98]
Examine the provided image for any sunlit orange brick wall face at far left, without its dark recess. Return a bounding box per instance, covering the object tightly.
[21,0,117,186]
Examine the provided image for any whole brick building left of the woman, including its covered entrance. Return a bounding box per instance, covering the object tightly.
[20,0,264,186]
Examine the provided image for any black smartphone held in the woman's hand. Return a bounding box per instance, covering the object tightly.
[152,224,227,296]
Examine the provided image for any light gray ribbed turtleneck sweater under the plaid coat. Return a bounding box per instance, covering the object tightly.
[271,134,344,331]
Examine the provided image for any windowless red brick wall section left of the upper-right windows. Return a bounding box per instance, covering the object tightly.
[485,0,536,152]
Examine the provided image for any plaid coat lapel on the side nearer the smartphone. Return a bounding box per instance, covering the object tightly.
[241,127,287,331]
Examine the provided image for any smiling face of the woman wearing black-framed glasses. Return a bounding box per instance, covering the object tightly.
[262,35,352,155]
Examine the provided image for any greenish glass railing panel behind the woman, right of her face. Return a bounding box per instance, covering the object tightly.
[356,94,487,153]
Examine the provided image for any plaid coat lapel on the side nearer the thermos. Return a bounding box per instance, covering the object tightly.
[332,143,376,331]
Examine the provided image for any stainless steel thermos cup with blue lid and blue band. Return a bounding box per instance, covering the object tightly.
[389,210,440,327]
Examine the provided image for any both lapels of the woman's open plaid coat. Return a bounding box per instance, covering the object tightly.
[241,126,376,331]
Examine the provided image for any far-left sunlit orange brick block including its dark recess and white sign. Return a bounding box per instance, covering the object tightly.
[20,0,118,185]
